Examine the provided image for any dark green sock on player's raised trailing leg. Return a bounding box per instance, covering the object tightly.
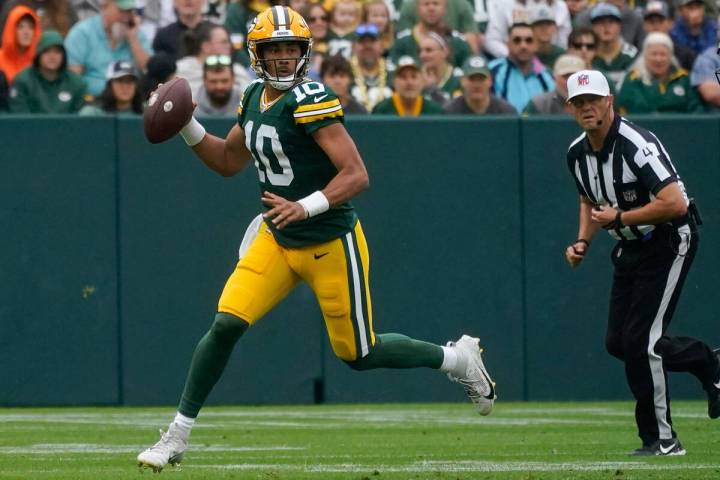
[346,333,444,370]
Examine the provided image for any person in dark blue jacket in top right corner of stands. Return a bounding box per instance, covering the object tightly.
[670,0,717,54]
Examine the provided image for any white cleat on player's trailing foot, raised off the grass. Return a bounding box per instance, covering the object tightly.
[447,335,497,415]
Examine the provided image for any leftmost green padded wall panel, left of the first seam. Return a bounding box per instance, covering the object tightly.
[0,117,119,405]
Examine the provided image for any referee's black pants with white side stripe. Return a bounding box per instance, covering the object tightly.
[605,225,720,445]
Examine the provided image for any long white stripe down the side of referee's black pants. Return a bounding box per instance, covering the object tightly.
[648,225,690,439]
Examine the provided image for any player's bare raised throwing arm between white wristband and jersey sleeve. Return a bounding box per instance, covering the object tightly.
[186,122,252,177]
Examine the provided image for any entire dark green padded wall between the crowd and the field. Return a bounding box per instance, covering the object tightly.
[0,116,720,405]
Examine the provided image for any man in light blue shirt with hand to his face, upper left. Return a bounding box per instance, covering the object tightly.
[65,0,152,96]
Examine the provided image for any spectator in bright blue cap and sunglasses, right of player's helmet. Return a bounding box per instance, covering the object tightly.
[350,24,392,111]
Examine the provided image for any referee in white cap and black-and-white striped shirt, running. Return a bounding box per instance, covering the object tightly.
[565,70,720,455]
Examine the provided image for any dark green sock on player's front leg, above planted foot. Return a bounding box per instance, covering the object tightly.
[178,313,249,418]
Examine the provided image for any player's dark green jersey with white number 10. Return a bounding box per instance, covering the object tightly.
[238,80,357,247]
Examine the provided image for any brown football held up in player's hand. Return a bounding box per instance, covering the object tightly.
[143,77,194,143]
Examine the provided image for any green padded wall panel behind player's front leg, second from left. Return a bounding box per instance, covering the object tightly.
[118,120,323,404]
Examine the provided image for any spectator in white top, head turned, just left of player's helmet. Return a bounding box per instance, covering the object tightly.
[177,23,250,99]
